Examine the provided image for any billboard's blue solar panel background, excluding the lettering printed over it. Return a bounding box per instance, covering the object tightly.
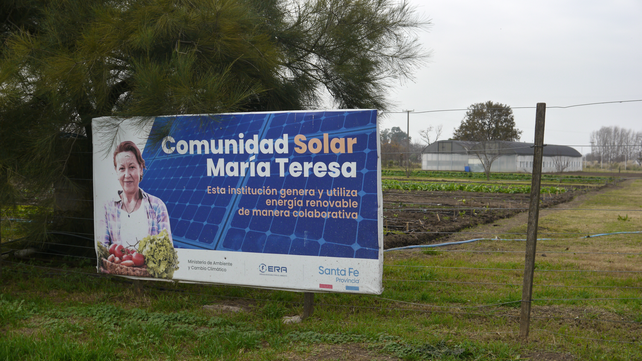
[141,110,379,259]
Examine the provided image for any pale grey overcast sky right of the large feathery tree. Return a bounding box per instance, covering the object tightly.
[380,0,642,153]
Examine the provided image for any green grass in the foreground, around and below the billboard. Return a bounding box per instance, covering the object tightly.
[0,180,642,360]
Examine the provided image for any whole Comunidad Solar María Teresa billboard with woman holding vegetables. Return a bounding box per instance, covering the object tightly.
[93,110,383,294]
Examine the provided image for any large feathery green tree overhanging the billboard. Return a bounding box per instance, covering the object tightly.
[0,0,426,246]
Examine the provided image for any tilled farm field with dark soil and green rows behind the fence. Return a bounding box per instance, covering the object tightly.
[383,172,642,248]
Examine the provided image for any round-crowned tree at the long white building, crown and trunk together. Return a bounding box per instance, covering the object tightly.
[453,101,522,180]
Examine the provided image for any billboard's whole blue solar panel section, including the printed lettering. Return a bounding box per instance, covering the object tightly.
[140,110,381,260]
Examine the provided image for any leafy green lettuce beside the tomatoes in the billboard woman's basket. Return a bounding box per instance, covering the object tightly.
[138,230,178,279]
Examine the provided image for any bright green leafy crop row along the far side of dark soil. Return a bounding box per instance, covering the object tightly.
[382,179,566,194]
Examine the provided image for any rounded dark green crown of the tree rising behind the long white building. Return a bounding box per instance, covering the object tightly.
[452,101,522,142]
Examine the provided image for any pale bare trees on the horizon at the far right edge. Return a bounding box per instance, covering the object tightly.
[586,126,642,164]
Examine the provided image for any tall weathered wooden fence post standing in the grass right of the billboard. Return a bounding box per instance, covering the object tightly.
[519,103,546,340]
